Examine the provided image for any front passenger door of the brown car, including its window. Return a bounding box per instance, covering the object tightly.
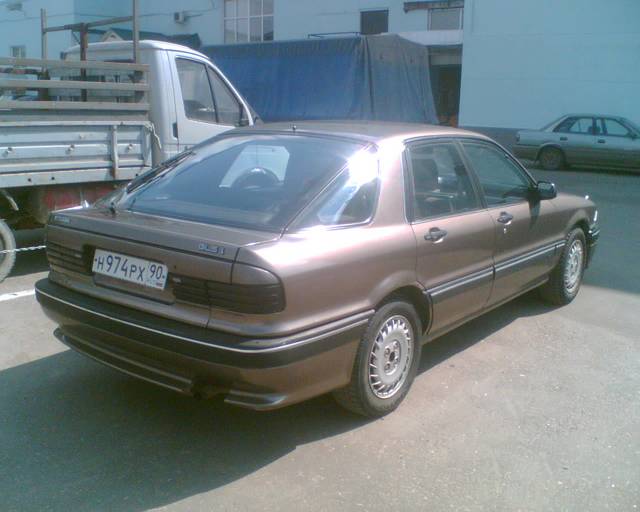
[462,141,562,304]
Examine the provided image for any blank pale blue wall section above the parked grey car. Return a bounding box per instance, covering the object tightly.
[460,0,640,128]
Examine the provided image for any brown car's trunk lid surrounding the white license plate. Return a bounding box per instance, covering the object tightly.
[47,209,279,326]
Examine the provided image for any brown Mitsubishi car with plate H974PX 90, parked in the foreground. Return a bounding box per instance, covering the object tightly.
[36,123,598,416]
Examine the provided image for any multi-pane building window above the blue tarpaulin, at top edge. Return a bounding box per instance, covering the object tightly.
[224,0,273,43]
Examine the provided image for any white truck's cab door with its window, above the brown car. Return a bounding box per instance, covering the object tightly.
[173,54,250,151]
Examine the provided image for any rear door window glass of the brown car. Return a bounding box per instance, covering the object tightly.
[408,142,480,220]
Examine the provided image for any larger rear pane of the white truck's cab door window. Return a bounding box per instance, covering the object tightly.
[176,59,216,123]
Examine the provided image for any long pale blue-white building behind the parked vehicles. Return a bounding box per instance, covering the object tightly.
[0,0,640,138]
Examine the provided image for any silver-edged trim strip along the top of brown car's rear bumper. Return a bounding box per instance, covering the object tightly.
[36,290,374,354]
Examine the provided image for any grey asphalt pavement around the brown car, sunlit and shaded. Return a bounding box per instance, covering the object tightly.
[0,166,640,511]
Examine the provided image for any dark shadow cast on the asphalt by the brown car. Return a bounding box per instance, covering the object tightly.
[0,290,548,511]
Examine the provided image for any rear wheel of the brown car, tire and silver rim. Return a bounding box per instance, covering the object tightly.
[333,300,422,418]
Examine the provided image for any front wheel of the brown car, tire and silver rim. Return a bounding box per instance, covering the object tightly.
[540,228,587,306]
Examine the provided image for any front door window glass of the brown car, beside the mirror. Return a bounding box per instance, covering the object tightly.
[462,142,531,207]
